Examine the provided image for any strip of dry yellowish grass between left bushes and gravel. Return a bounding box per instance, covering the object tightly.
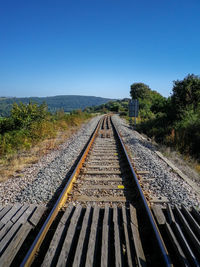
[0,124,81,182]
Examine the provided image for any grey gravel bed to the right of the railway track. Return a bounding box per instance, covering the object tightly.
[113,115,200,208]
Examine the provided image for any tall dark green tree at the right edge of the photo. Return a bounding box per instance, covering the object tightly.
[171,74,200,160]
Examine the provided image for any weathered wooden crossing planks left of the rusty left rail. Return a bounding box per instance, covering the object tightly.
[0,204,46,266]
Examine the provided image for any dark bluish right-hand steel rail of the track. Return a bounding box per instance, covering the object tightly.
[111,118,173,266]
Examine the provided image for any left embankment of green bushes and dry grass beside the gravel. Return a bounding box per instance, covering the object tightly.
[0,103,92,181]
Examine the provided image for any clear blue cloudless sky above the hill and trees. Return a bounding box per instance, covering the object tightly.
[0,0,200,98]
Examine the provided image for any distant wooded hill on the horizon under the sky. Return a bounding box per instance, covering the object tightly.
[0,95,113,117]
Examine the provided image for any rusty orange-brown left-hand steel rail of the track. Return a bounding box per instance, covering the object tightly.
[20,118,103,267]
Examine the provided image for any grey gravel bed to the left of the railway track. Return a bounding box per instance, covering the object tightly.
[0,116,100,205]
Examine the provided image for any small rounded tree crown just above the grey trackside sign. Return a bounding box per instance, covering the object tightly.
[130,83,151,99]
